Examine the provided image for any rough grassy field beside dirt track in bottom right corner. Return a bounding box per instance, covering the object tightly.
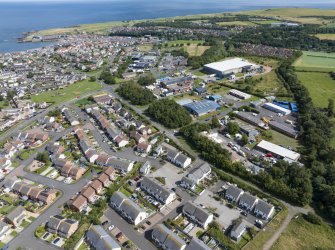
[271,216,335,250]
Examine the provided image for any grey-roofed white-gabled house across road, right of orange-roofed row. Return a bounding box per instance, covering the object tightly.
[110,192,148,225]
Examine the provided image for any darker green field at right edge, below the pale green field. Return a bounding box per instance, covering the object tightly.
[296,72,335,107]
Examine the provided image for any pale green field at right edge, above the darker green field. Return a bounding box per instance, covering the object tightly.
[293,51,335,72]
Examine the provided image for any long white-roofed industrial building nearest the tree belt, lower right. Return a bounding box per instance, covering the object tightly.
[257,140,300,161]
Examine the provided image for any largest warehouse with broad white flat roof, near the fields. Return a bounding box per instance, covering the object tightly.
[204,58,258,77]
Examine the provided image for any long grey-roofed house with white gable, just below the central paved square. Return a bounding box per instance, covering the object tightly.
[140,177,176,204]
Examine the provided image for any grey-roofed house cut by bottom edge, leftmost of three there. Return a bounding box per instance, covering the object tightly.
[86,225,121,250]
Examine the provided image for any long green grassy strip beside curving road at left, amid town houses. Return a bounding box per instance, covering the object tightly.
[31,80,102,104]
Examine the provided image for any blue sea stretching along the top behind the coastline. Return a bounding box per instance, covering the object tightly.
[0,0,335,53]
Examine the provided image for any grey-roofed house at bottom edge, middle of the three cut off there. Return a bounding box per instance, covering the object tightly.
[151,224,186,250]
